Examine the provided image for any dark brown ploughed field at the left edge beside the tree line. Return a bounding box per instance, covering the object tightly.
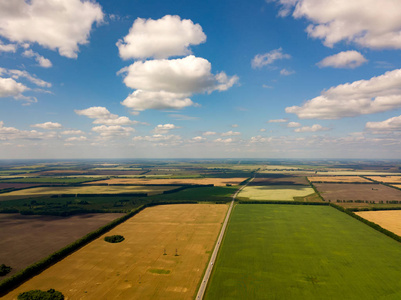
[0,214,124,279]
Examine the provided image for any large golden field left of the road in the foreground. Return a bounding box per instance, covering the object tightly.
[3,204,228,300]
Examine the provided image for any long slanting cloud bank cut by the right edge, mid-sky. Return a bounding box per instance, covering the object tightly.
[285,69,401,119]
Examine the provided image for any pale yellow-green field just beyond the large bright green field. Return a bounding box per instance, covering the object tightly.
[238,185,315,201]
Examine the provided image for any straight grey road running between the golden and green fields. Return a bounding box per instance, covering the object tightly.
[195,175,256,300]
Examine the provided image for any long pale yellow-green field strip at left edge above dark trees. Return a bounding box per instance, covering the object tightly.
[0,185,177,201]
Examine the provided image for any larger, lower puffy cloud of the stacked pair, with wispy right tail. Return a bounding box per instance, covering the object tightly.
[118,55,238,111]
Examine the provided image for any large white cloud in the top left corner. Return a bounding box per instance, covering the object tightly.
[0,0,103,58]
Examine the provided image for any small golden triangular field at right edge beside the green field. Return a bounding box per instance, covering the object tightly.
[355,210,401,236]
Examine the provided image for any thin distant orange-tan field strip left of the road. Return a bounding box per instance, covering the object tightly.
[86,178,247,186]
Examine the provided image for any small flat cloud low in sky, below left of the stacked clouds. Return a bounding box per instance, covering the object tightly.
[74,106,139,125]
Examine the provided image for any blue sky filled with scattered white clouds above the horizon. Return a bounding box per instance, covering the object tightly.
[0,0,401,159]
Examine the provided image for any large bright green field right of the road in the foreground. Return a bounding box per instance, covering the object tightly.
[205,204,401,300]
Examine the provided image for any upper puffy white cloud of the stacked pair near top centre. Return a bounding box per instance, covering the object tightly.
[117,15,206,59]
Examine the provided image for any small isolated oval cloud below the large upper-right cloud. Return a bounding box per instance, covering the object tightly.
[317,50,367,69]
